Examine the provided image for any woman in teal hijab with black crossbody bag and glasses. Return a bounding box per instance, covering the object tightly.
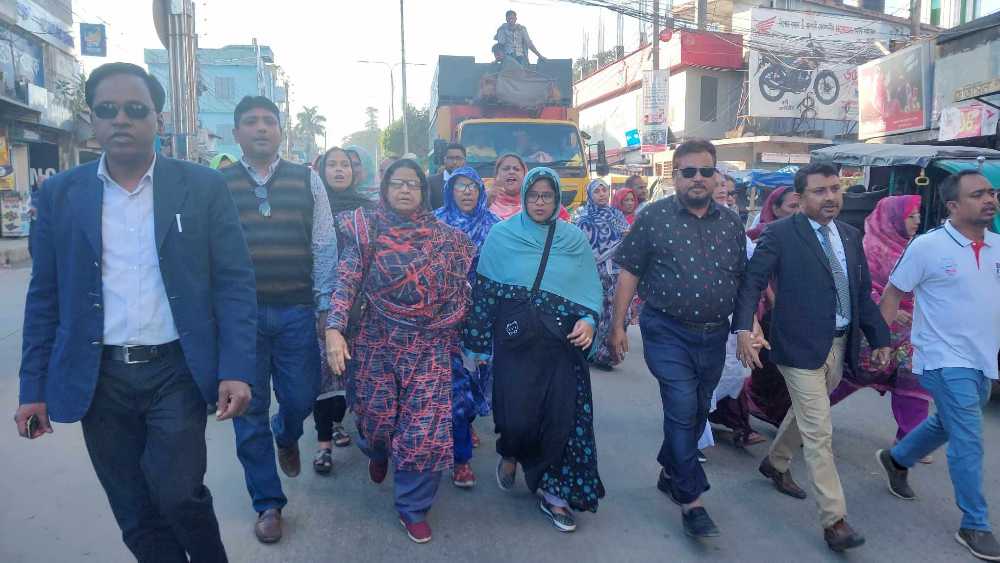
[462,167,604,532]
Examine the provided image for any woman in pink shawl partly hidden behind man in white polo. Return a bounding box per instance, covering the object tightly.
[830,195,932,463]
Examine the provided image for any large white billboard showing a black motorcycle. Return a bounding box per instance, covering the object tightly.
[749,8,907,121]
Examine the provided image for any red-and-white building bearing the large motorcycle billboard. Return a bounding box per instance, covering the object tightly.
[574,0,937,178]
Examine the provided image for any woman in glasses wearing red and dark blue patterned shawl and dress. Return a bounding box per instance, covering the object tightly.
[326,159,476,543]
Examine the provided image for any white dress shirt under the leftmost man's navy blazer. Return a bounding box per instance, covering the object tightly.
[97,155,178,346]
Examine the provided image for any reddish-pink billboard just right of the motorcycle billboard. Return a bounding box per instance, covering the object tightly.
[858,43,931,139]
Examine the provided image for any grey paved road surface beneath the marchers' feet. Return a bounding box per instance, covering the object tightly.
[0,269,1000,563]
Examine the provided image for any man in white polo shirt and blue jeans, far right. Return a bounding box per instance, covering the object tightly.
[877,170,1000,561]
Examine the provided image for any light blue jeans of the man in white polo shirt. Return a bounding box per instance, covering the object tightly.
[892,368,992,530]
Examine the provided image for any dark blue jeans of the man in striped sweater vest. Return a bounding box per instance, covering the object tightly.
[233,304,320,513]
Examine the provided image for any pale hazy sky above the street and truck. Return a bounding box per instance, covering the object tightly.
[73,0,638,145]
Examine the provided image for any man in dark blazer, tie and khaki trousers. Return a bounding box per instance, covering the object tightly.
[733,164,889,552]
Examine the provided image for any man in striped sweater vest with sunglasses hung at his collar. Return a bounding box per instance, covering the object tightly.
[223,96,337,543]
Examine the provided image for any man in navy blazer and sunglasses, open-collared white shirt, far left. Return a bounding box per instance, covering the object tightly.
[15,63,257,561]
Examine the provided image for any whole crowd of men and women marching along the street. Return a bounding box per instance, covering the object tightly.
[15,63,1000,561]
